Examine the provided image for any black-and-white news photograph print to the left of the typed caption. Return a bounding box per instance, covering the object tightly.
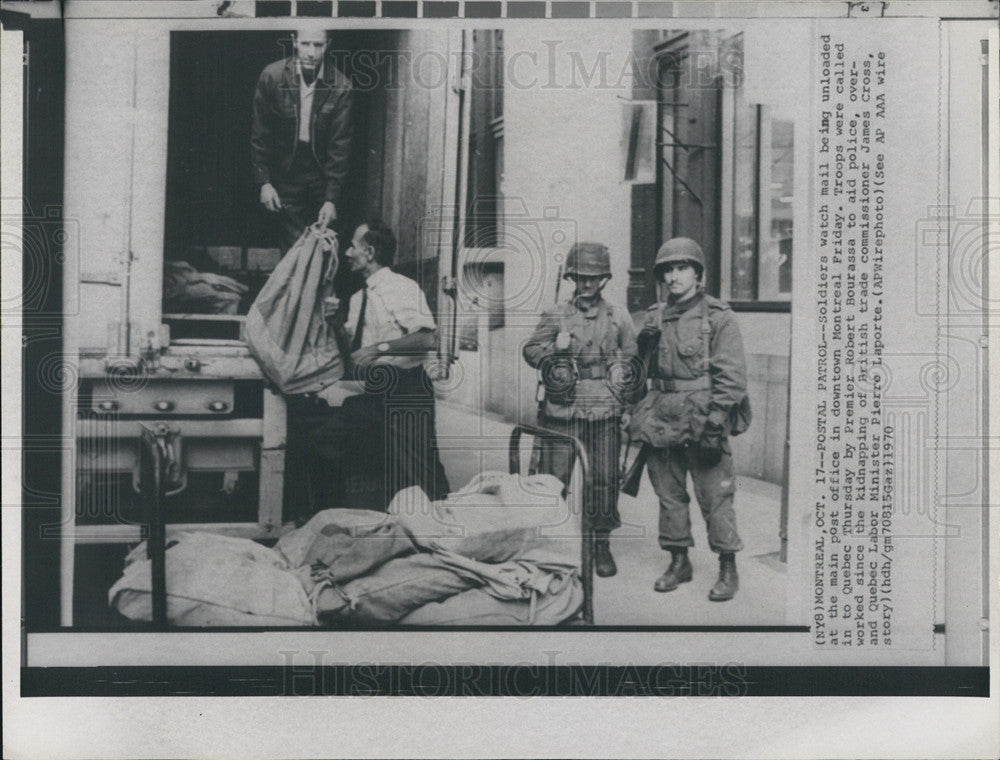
[26,20,805,631]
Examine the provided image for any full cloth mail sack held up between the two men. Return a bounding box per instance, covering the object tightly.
[244,227,344,394]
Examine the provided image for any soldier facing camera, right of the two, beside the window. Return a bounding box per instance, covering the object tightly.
[628,238,750,602]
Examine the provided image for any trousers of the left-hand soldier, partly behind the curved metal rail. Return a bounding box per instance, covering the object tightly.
[535,415,622,534]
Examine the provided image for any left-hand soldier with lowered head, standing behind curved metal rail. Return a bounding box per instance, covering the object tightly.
[523,243,636,577]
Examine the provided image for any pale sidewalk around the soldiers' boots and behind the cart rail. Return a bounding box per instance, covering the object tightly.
[437,401,787,626]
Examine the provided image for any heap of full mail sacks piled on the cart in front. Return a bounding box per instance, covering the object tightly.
[109,472,583,626]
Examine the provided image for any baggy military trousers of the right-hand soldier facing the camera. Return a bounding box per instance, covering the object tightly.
[646,446,743,553]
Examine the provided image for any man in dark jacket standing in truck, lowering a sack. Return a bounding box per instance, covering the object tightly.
[250,29,353,250]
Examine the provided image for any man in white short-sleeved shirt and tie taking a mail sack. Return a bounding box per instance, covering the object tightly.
[292,219,449,510]
